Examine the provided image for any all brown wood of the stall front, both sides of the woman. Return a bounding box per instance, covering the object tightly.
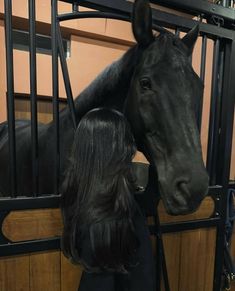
[0,198,215,291]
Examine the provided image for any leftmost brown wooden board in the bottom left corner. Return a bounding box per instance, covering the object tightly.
[0,256,29,291]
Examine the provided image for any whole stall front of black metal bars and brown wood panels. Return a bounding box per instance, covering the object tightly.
[0,0,235,291]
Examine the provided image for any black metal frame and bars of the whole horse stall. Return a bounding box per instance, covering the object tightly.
[0,0,235,291]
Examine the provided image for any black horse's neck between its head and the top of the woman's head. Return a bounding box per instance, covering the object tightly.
[61,45,142,119]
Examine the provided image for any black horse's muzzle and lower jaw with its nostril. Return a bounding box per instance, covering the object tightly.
[143,134,209,215]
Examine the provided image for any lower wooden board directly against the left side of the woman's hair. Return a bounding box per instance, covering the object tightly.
[61,253,82,291]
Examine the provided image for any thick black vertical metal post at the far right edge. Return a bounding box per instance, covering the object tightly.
[213,41,235,291]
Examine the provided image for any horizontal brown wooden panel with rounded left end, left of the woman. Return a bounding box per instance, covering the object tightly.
[2,209,62,242]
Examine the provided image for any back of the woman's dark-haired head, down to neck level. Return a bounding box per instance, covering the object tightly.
[73,108,136,175]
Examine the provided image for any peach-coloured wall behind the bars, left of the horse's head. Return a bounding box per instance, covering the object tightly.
[0,0,133,122]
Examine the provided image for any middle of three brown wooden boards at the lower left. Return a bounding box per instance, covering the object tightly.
[29,251,60,291]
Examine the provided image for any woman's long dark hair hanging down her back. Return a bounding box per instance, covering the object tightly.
[61,108,138,272]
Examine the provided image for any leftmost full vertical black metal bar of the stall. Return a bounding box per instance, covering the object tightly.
[4,0,17,197]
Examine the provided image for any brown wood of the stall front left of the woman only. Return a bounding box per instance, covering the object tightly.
[0,209,82,291]
